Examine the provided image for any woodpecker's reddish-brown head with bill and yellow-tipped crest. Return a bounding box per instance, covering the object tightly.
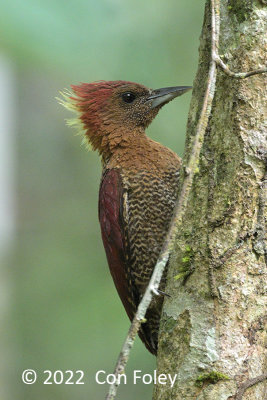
[60,81,191,154]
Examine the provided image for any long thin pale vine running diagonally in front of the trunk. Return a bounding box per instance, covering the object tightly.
[106,0,219,400]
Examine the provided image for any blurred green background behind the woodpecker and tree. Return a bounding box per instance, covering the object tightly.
[0,0,204,400]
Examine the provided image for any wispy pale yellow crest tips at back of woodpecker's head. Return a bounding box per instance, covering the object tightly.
[56,89,92,150]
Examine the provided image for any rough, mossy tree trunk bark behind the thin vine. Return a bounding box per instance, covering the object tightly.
[153,0,267,400]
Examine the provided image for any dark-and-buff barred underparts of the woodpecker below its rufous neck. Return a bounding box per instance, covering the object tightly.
[121,169,179,287]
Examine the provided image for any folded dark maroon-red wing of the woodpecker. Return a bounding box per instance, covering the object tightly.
[99,169,136,319]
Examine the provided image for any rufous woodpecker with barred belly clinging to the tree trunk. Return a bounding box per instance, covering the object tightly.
[61,81,191,355]
